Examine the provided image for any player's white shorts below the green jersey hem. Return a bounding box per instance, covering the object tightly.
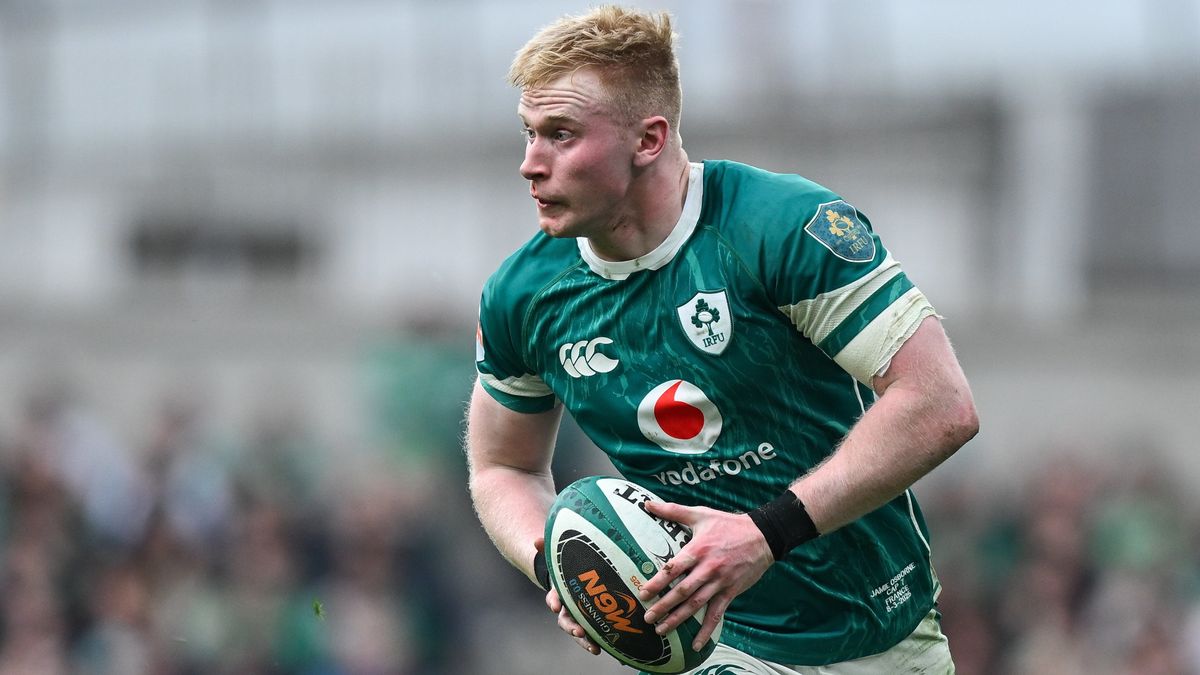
[672,609,954,675]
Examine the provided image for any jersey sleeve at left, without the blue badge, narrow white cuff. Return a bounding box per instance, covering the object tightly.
[475,270,554,413]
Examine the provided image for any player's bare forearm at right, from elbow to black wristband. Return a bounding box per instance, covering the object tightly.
[792,360,979,533]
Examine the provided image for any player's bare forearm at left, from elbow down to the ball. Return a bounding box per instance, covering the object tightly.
[470,466,554,583]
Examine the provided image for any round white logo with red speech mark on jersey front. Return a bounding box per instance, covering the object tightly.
[637,380,721,455]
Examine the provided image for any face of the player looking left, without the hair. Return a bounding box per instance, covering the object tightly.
[517,70,637,237]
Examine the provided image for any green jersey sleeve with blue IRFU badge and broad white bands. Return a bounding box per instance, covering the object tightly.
[767,195,936,387]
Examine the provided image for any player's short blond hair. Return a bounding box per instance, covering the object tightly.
[509,5,683,130]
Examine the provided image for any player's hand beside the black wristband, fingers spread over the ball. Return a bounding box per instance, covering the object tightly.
[640,501,775,649]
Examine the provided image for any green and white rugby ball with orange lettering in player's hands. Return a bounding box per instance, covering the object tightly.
[544,476,721,673]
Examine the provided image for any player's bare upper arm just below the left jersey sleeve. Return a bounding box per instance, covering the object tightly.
[467,381,563,473]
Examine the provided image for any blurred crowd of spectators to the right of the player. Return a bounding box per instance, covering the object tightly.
[922,444,1200,675]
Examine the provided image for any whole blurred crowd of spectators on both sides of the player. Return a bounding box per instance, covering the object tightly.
[0,353,1200,675]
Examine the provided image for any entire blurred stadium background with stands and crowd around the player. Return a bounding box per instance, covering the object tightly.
[0,0,1200,675]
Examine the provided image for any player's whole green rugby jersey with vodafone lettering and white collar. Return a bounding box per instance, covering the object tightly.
[476,161,937,665]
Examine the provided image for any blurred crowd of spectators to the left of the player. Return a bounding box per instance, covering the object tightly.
[0,353,469,675]
